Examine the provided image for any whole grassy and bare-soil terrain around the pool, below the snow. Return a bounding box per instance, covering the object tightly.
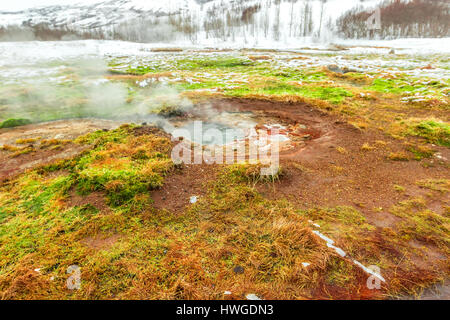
[0,43,450,299]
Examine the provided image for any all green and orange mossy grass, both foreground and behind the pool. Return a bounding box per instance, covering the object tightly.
[0,48,450,299]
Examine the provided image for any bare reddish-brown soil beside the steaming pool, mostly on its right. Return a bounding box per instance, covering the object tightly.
[168,99,450,225]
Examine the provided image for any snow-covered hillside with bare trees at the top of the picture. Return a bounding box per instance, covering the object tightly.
[0,0,381,44]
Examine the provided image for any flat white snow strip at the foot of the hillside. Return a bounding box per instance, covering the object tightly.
[0,38,450,67]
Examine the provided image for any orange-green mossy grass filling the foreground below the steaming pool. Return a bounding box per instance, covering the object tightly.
[0,126,448,299]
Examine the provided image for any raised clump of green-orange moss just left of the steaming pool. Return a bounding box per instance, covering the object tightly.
[75,126,173,206]
